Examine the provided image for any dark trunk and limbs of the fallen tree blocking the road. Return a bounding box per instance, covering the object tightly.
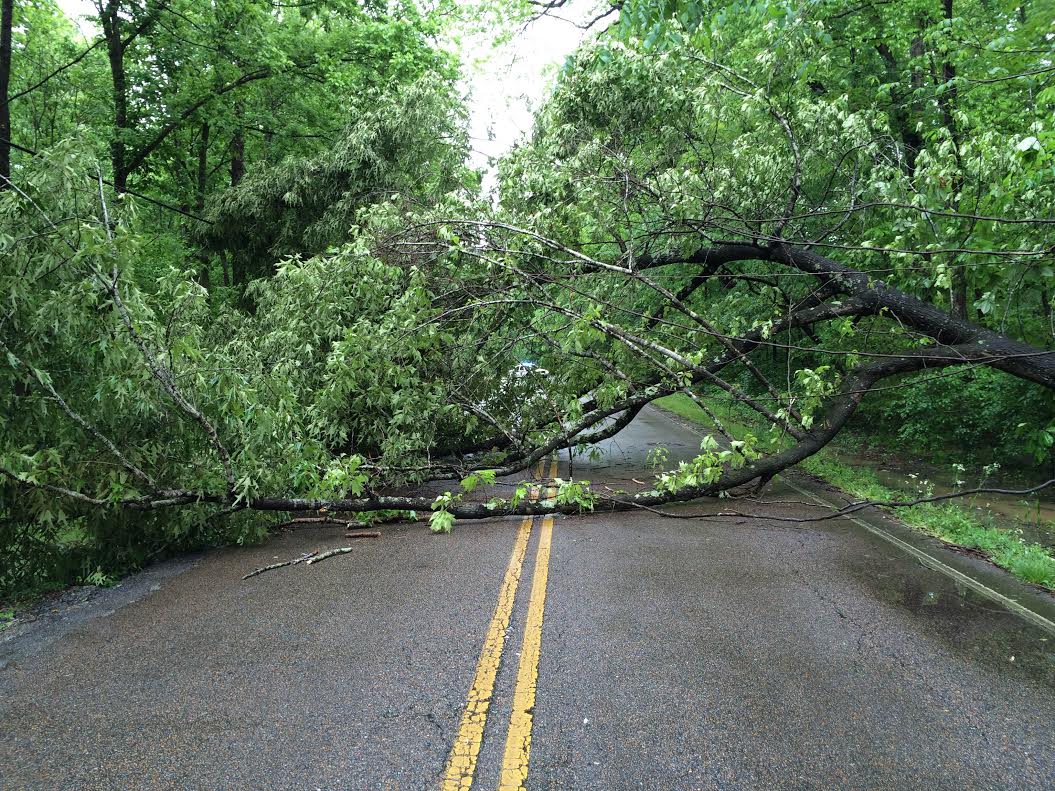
[0,196,1055,527]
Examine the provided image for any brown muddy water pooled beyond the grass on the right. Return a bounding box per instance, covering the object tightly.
[832,448,1055,546]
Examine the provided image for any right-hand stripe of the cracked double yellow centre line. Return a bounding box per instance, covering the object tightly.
[498,517,553,791]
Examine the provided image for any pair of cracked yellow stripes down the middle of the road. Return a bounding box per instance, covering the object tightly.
[443,459,557,791]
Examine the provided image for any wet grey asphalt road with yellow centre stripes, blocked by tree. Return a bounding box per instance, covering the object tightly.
[0,404,1055,790]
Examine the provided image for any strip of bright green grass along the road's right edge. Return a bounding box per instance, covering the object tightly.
[655,393,1055,591]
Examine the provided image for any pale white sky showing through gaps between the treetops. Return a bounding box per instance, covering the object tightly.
[58,0,598,187]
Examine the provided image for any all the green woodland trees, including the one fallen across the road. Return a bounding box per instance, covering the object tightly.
[0,0,1055,593]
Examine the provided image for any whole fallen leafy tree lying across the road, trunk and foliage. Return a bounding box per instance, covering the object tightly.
[0,4,1055,590]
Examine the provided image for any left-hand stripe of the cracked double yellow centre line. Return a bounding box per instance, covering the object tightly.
[443,517,533,791]
